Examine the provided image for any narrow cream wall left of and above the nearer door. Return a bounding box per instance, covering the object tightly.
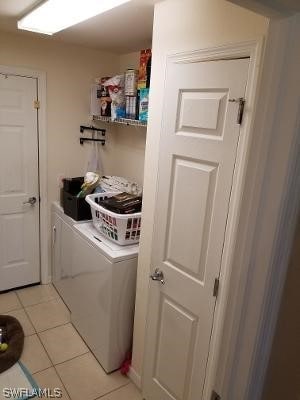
[132,0,268,382]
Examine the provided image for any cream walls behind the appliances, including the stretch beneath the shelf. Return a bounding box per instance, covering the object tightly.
[0,32,146,282]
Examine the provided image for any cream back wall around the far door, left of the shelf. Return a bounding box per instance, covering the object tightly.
[0,32,119,280]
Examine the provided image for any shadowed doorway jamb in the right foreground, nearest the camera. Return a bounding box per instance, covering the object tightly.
[215,14,300,400]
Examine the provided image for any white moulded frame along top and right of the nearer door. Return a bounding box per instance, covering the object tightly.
[141,37,264,399]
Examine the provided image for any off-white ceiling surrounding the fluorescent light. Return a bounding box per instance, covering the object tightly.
[0,0,159,54]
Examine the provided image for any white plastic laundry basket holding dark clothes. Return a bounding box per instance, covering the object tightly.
[85,192,141,246]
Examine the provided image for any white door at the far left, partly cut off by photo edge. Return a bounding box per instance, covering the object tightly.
[0,73,40,291]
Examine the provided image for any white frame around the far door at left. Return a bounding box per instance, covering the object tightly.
[0,65,50,284]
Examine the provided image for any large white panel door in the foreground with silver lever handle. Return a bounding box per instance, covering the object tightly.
[144,59,249,400]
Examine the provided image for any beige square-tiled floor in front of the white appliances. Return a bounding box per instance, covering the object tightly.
[0,285,142,400]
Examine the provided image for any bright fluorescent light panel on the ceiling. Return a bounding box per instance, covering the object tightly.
[18,0,130,35]
